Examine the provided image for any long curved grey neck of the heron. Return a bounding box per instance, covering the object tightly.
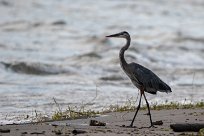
[119,37,131,68]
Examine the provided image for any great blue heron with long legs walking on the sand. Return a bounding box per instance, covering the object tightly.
[106,31,171,127]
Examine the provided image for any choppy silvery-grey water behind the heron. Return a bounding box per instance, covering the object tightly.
[0,0,204,123]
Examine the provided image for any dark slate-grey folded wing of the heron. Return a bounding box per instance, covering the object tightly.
[130,63,171,94]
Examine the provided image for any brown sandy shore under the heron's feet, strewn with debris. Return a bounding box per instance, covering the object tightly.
[0,109,204,136]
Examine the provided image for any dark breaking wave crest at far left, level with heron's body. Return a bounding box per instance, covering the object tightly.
[0,62,70,75]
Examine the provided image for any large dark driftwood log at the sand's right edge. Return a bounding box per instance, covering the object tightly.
[170,123,204,132]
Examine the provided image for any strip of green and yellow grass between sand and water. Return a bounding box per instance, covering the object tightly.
[0,100,204,125]
